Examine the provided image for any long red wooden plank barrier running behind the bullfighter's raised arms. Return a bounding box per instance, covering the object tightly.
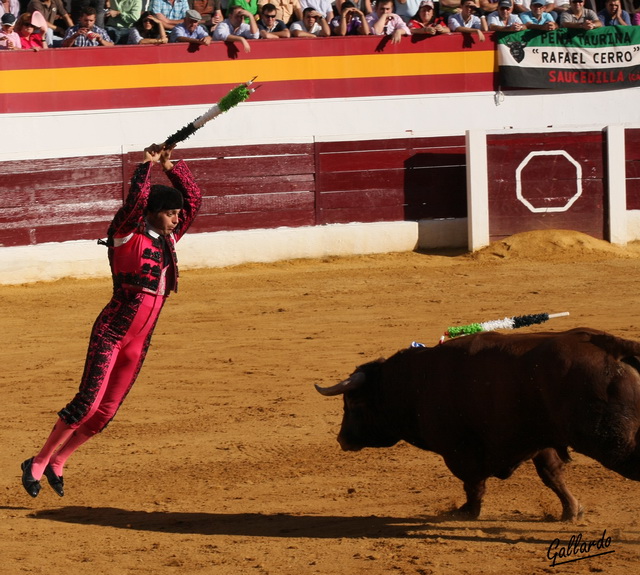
[0,136,466,250]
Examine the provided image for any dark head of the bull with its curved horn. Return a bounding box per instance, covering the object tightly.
[315,360,400,451]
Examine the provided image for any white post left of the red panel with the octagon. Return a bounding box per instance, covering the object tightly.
[465,130,489,252]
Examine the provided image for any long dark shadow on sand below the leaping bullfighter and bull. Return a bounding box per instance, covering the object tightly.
[31,507,640,545]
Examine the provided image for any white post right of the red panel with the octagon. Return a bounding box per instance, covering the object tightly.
[606,125,627,245]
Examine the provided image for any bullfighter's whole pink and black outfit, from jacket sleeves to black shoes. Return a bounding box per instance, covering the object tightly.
[22,161,202,497]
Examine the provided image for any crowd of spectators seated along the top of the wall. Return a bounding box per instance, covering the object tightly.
[0,0,640,52]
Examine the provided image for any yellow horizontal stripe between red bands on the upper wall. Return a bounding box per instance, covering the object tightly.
[0,50,495,94]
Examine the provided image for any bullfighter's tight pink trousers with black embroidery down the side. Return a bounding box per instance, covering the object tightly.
[58,290,166,434]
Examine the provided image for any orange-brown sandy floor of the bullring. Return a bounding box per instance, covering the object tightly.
[0,232,640,575]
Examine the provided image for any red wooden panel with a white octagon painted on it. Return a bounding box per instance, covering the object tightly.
[487,131,606,241]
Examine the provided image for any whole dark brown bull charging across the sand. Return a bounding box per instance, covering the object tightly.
[316,328,640,520]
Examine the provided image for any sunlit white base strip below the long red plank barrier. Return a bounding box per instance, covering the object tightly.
[0,222,422,285]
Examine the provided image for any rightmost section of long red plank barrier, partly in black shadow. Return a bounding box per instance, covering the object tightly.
[316,136,467,224]
